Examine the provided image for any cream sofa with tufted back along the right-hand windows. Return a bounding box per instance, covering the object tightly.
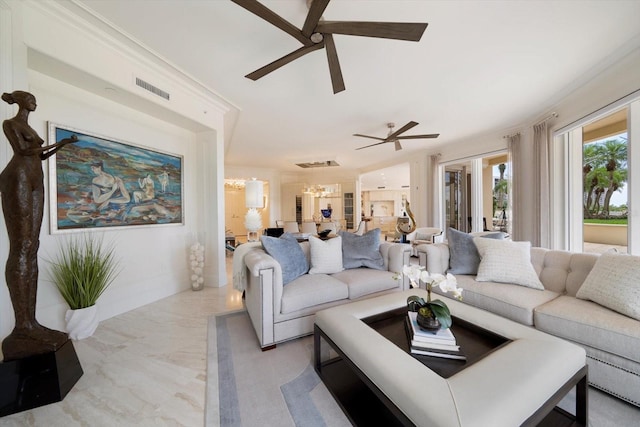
[417,240,640,406]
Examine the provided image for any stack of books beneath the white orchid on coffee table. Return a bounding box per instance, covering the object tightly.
[406,311,466,360]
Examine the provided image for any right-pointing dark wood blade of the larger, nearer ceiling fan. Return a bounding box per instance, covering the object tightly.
[316,21,428,42]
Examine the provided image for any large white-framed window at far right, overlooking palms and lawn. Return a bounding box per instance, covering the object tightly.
[551,94,640,253]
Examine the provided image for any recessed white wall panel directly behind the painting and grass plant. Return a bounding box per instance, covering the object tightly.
[29,72,198,328]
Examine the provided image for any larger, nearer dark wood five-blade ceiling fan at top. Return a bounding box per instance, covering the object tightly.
[231,0,428,93]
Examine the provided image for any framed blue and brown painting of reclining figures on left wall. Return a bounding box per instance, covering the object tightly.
[48,123,184,233]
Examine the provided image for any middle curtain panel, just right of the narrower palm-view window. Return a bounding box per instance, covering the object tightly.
[507,133,526,240]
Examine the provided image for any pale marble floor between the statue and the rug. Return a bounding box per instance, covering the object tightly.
[0,258,243,427]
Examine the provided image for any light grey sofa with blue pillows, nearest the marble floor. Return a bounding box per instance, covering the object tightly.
[239,234,411,350]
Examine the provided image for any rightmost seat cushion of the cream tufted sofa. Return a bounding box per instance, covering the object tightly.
[534,295,640,362]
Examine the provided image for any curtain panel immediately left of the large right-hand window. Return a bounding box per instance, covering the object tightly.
[531,120,551,248]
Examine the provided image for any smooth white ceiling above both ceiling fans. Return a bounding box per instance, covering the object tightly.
[76,0,640,188]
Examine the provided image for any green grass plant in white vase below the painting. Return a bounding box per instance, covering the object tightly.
[49,234,120,340]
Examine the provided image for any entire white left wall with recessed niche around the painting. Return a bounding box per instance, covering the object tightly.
[0,0,226,352]
